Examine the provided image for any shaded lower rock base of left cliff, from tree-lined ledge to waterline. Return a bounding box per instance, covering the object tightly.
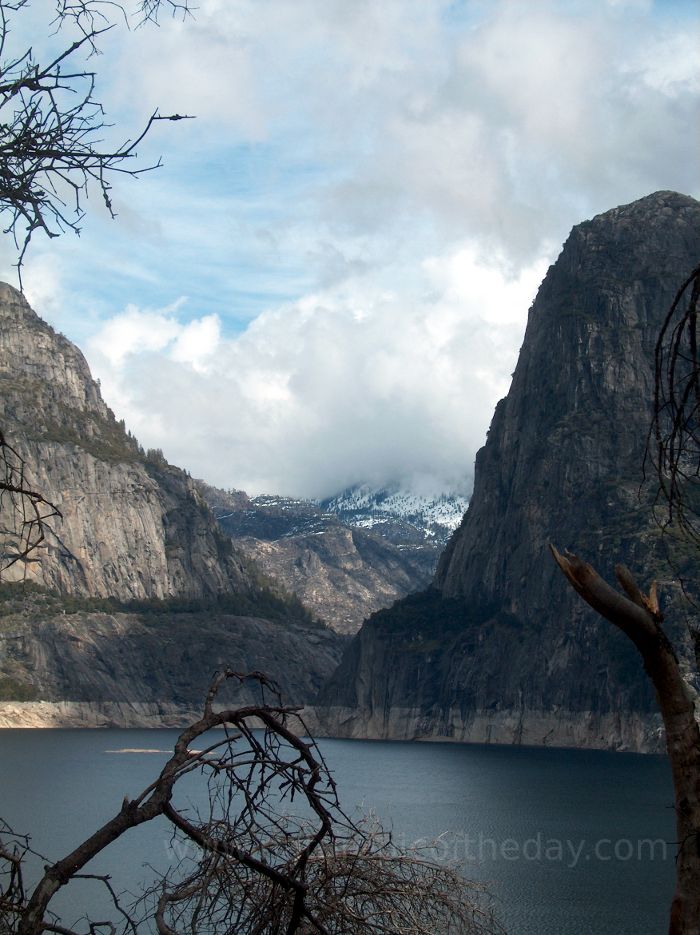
[0,585,339,726]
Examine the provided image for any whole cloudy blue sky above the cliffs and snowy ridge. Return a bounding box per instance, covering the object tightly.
[0,0,700,497]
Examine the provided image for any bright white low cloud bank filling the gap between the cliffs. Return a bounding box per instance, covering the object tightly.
[88,246,545,497]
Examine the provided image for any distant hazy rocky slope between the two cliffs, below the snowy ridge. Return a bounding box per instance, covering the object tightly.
[198,482,437,633]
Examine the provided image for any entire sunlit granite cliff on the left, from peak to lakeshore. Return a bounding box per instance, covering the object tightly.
[0,284,340,725]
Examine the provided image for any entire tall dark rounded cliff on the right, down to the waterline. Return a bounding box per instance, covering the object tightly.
[321,192,700,749]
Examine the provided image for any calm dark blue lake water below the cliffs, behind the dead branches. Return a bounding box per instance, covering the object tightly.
[0,730,675,935]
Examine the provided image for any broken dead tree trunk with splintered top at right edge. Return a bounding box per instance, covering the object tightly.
[551,546,700,935]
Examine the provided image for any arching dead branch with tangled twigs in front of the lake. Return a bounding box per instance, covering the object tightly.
[0,671,501,935]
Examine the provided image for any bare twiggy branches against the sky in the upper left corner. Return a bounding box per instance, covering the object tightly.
[0,0,190,285]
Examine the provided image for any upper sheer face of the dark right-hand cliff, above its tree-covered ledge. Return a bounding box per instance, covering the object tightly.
[435,192,700,604]
